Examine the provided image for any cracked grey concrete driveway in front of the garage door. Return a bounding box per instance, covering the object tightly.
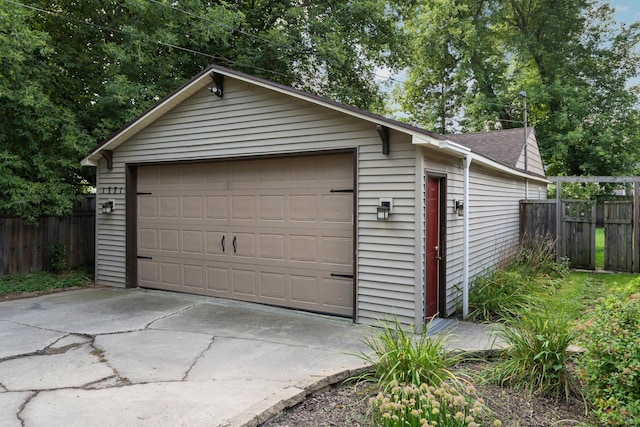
[0,289,366,427]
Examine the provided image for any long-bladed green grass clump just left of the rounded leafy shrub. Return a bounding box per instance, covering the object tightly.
[489,310,581,401]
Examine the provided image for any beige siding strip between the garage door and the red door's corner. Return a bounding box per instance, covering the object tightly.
[357,131,419,324]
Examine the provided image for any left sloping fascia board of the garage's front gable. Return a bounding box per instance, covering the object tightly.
[80,73,211,167]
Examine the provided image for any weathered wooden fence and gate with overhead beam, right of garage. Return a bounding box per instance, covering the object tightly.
[520,177,640,272]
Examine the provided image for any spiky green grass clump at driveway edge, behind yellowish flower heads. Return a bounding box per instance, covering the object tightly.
[358,318,460,389]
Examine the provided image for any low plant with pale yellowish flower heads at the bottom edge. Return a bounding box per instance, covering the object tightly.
[369,381,502,427]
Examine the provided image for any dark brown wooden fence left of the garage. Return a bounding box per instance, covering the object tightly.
[0,195,96,276]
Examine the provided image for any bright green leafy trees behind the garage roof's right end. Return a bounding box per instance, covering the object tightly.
[400,0,640,175]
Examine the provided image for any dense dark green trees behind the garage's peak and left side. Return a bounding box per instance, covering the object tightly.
[0,0,403,220]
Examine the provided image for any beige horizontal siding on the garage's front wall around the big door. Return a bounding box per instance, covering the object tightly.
[96,78,416,324]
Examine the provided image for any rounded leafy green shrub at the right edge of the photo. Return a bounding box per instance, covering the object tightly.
[579,293,640,426]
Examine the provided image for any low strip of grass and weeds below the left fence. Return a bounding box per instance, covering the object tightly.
[0,268,93,295]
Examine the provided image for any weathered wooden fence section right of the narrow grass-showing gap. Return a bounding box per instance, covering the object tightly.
[604,201,633,272]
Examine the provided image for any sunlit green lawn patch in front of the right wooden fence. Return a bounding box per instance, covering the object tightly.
[543,271,639,320]
